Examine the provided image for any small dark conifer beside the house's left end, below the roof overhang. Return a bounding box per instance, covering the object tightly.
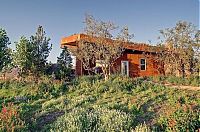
[57,47,72,79]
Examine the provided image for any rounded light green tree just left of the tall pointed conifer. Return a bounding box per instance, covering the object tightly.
[13,36,33,77]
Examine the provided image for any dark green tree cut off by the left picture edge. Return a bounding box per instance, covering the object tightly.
[0,28,11,72]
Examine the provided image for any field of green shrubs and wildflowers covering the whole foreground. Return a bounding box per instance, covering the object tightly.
[0,76,200,131]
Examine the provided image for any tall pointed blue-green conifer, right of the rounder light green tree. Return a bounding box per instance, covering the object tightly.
[30,26,52,78]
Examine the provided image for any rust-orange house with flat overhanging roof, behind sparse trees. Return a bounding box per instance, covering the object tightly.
[61,34,163,77]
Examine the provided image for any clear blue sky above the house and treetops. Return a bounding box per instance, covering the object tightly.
[0,0,200,63]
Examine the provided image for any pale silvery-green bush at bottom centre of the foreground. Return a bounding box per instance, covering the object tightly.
[45,107,131,132]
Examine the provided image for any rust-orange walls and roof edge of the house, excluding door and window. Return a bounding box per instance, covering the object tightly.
[61,34,164,77]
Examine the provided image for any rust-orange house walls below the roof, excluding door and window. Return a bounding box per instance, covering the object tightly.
[63,47,160,77]
